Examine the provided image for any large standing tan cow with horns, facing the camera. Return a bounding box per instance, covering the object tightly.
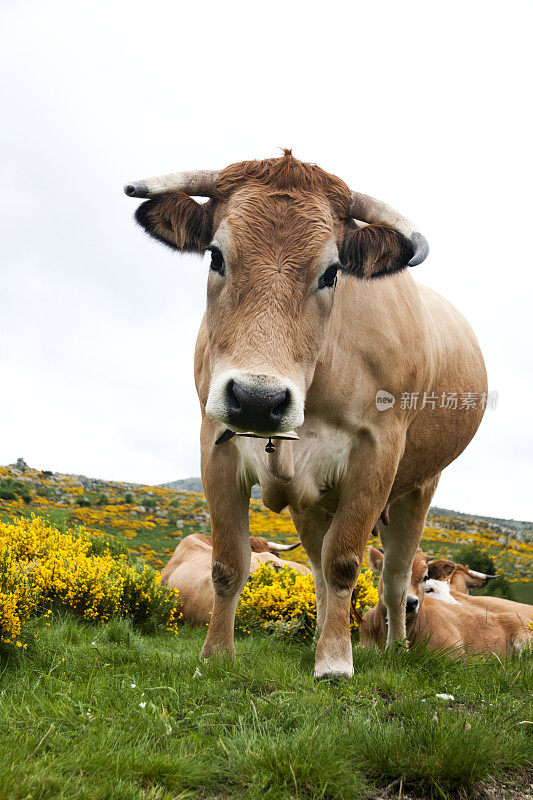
[126,152,487,678]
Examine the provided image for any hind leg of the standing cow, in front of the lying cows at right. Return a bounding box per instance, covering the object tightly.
[380,474,440,645]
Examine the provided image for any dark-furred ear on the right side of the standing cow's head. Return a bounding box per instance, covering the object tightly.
[340,220,414,278]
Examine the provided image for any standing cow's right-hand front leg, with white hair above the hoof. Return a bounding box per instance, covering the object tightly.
[315,432,402,679]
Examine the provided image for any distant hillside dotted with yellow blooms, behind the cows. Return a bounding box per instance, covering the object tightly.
[0,459,533,602]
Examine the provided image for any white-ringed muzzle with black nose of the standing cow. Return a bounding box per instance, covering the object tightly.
[206,371,303,436]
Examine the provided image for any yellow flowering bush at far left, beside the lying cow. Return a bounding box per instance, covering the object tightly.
[0,516,181,647]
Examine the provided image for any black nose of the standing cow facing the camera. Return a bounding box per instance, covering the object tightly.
[226,381,291,433]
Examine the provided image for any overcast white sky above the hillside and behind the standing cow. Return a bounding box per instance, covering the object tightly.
[0,0,533,520]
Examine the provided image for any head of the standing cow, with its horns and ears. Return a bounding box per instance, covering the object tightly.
[125,151,428,435]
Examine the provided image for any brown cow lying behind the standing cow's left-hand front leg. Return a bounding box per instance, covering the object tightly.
[161,533,310,625]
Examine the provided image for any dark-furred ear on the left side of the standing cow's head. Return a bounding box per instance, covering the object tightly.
[135,191,215,253]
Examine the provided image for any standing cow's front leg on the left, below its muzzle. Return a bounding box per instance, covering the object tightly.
[198,420,251,658]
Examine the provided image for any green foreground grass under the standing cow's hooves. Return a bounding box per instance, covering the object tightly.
[0,617,533,800]
